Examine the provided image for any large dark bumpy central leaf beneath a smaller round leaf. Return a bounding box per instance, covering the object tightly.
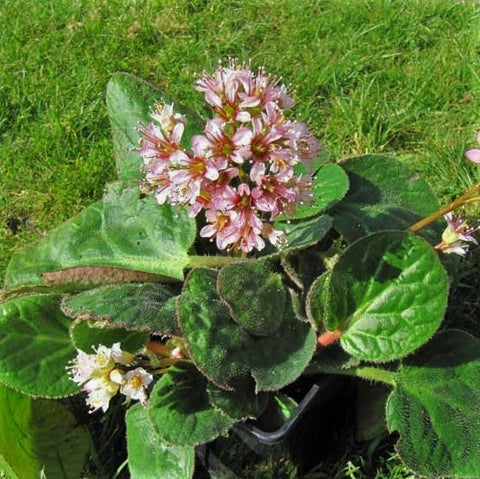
[178,268,315,391]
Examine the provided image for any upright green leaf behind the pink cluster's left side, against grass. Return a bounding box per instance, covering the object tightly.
[107,73,201,179]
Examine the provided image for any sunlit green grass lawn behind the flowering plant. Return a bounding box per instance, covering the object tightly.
[0,0,480,478]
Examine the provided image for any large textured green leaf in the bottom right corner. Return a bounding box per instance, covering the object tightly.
[387,330,480,478]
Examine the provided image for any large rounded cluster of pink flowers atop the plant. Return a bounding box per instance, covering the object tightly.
[137,62,320,253]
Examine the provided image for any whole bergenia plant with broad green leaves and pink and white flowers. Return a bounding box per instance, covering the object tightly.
[0,62,480,479]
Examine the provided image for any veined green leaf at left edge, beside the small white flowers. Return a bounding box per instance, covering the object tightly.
[0,295,78,397]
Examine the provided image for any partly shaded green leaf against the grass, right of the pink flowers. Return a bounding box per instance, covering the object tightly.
[330,155,438,242]
